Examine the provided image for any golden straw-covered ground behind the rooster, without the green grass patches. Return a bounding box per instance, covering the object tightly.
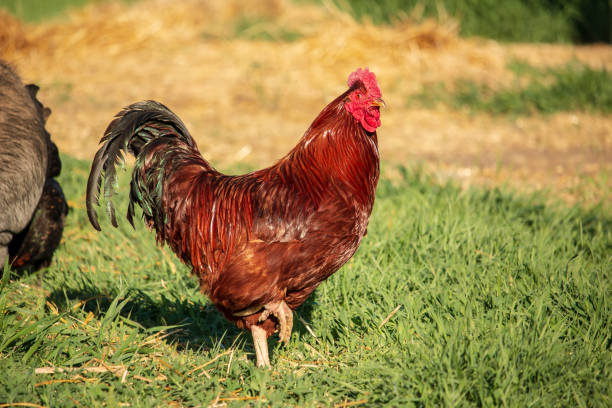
[0,0,612,203]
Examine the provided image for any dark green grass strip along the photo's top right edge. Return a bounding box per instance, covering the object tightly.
[314,0,612,43]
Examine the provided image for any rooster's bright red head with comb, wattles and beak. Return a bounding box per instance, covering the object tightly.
[344,68,385,132]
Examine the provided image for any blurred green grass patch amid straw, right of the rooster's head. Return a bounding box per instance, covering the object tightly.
[408,61,612,115]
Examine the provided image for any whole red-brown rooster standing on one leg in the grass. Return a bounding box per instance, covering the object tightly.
[87,68,384,367]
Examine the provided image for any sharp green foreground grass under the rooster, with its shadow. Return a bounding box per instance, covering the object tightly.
[0,157,612,407]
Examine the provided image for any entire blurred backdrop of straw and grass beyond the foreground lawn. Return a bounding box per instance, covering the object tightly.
[0,0,612,203]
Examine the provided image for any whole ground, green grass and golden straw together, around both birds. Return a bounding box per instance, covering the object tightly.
[0,0,612,408]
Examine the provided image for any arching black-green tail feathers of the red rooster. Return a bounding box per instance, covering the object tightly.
[86,101,195,231]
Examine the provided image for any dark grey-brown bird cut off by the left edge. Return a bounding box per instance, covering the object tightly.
[0,61,68,272]
